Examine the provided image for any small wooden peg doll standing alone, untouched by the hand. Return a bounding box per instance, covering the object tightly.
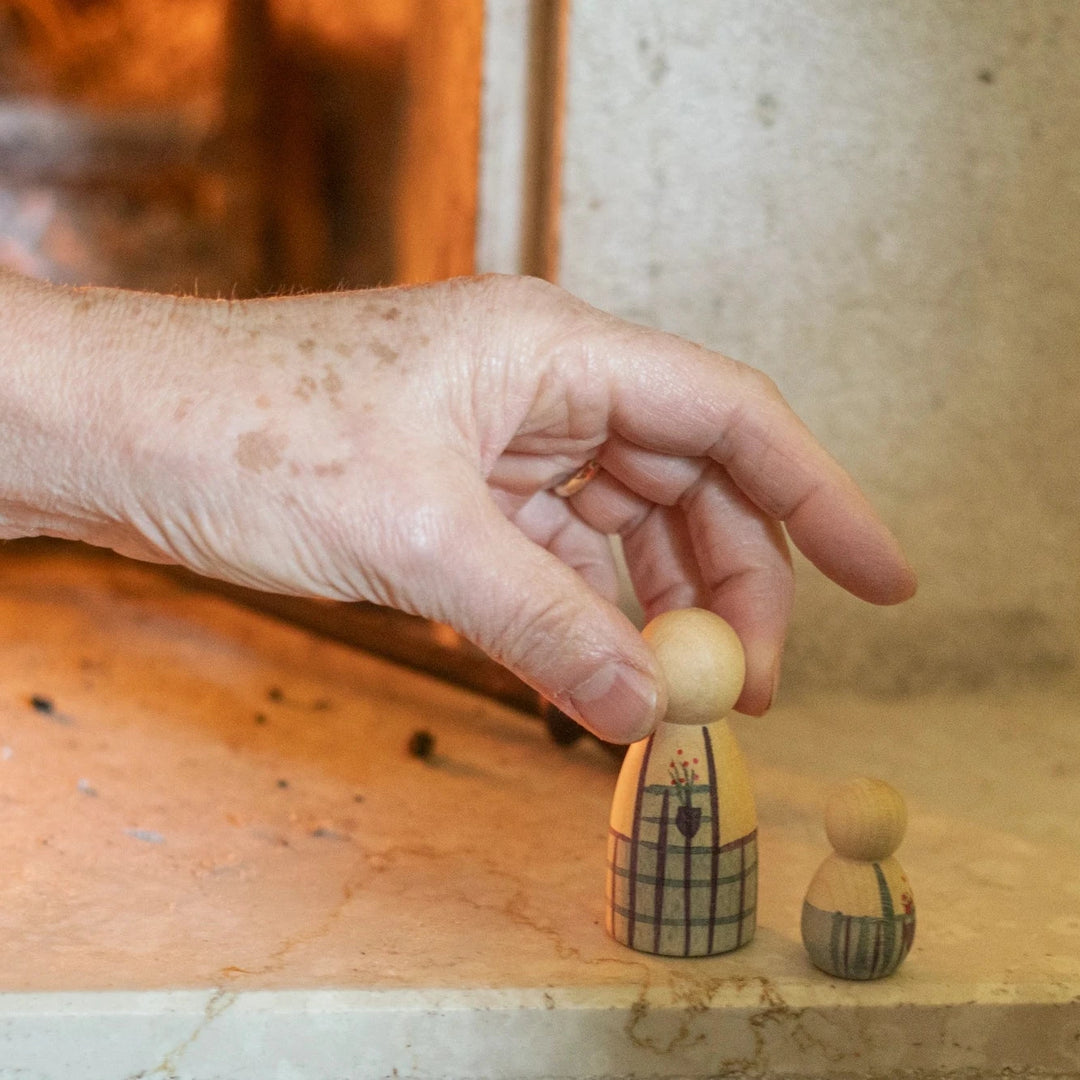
[802,778,915,980]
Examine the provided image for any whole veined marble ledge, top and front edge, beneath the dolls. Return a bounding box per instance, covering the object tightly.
[0,558,1080,1080]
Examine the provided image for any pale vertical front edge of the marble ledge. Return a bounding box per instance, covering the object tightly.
[0,986,1080,1080]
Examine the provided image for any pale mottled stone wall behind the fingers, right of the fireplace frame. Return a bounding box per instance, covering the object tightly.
[559,0,1080,694]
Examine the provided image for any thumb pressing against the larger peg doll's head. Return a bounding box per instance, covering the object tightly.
[425,490,666,743]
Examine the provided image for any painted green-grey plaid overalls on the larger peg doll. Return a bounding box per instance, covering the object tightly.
[607,784,757,956]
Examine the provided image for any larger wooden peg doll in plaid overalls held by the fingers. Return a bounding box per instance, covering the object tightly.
[607,608,757,956]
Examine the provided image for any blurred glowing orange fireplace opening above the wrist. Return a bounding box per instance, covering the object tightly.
[0,0,483,296]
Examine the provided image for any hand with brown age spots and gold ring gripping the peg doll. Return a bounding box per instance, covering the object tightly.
[0,278,915,741]
